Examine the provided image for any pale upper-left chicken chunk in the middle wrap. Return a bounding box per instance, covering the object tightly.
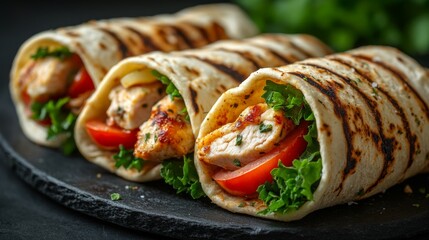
[107,81,165,129]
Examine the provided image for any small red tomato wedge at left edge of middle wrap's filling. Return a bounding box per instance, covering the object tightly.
[85,120,138,149]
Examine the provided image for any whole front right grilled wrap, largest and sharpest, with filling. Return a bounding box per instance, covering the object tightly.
[195,46,429,221]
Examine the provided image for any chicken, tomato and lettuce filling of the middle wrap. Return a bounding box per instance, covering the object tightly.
[85,68,204,198]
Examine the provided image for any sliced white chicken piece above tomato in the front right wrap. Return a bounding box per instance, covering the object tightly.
[198,103,295,170]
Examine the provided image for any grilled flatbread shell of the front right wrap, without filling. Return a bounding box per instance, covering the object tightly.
[195,46,429,221]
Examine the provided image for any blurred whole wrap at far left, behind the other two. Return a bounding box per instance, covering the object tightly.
[10,4,257,154]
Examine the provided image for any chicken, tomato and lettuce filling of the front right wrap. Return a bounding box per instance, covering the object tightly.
[197,80,322,214]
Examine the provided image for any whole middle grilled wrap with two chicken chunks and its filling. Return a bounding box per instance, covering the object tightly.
[75,34,330,186]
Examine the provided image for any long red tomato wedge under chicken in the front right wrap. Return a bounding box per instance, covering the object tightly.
[213,122,309,197]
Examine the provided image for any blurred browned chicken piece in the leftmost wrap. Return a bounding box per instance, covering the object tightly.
[20,56,82,102]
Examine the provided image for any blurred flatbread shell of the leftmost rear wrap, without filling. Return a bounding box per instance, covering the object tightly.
[10,4,257,147]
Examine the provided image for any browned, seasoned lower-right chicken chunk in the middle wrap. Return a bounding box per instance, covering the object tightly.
[134,96,195,162]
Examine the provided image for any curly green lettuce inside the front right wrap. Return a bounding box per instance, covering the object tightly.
[257,81,322,214]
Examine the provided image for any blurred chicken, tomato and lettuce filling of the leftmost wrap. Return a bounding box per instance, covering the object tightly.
[18,46,95,154]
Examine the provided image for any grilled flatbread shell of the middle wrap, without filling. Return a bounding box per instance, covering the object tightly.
[75,34,330,182]
